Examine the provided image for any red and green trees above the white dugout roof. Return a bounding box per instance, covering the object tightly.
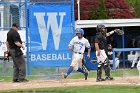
[75,0,137,20]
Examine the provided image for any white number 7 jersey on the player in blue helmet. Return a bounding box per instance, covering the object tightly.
[68,36,90,53]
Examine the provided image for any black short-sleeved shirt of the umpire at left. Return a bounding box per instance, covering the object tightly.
[7,28,22,49]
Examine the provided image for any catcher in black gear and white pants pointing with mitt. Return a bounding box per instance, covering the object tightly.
[95,24,123,82]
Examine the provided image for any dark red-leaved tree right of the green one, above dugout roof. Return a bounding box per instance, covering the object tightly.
[105,0,136,18]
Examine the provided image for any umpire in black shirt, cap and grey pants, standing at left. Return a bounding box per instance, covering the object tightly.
[6,23,28,82]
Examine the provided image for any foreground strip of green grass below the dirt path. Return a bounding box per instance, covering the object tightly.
[0,85,140,93]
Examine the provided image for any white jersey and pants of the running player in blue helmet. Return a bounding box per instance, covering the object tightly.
[68,36,90,70]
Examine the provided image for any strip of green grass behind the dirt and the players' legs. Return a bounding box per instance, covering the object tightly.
[0,68,139,82]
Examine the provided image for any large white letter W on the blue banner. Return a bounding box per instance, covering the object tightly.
[34,12,66,50]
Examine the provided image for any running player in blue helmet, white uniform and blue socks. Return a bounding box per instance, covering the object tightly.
[64,28,91,80]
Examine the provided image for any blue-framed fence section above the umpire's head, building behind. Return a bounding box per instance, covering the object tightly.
[0,0,26,31]
